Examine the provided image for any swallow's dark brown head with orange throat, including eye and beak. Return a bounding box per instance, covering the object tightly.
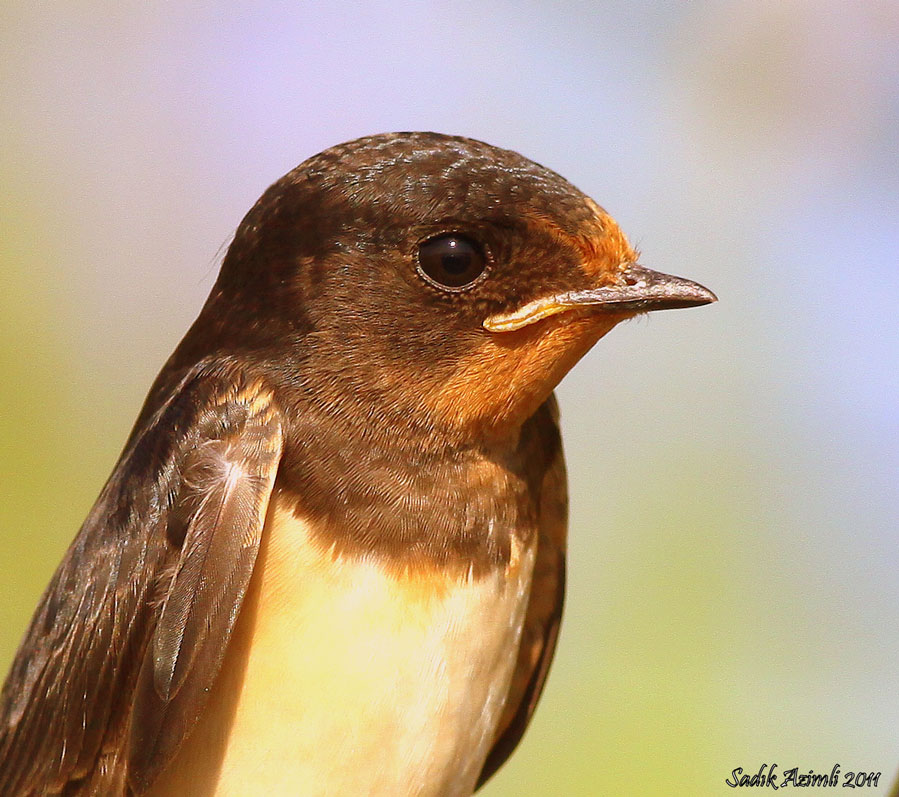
[201,133,715,437]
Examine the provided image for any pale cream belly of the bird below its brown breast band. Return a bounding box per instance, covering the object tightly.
[152,494,535,797]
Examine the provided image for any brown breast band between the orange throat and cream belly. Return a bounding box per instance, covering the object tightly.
[276,386,540,576]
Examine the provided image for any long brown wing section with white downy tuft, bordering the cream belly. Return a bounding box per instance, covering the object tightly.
[129,398,281,791]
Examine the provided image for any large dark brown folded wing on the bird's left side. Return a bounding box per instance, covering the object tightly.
[0,365,282,797]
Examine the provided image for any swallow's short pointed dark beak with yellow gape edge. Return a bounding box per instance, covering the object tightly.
[484,263,718,332]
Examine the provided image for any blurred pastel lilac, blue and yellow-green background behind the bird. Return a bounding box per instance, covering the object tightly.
[0,0,899,797]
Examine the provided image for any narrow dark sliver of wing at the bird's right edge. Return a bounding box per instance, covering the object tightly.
[478,397,568,787]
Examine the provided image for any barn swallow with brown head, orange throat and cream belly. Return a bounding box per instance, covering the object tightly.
[0,133,715,797]
